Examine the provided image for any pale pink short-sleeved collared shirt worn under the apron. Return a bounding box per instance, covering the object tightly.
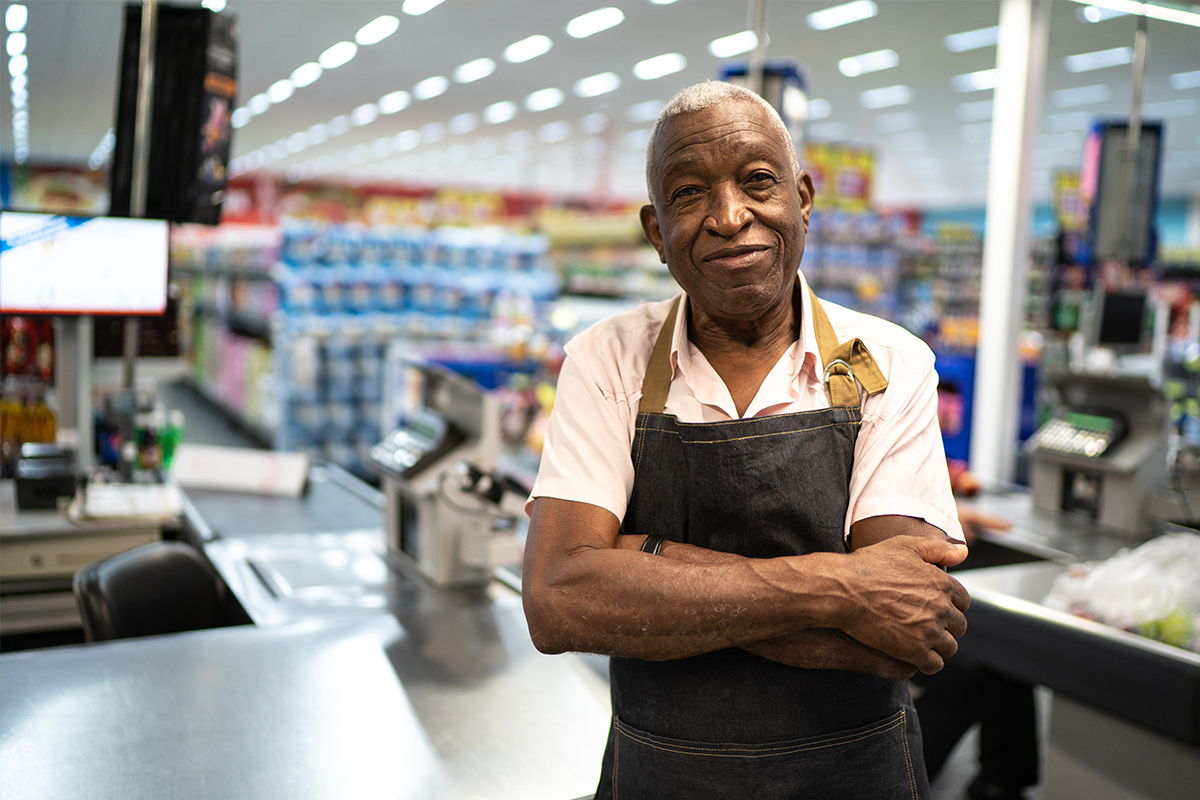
[526,275,962,539]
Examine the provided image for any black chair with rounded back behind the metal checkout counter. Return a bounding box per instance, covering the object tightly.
[72,542,228,642]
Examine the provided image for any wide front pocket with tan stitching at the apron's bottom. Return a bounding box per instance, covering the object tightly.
[612,709,920,800]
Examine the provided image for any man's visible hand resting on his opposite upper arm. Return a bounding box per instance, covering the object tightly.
[840,535,971,674]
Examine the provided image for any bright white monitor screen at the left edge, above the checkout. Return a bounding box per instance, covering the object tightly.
[0,211,168,314]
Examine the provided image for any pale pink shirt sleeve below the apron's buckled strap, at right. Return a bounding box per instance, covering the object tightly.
[845,351,962,539]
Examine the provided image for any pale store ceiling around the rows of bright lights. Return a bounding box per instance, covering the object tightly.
[9,0,1200,207]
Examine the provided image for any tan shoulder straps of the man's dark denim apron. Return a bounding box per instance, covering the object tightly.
[637,288,888,414]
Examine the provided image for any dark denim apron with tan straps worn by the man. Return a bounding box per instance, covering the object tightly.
[595,291,929,800]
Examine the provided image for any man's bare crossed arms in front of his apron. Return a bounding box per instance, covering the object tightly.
[522,497,970,680]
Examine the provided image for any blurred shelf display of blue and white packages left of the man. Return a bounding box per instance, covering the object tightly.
[179,219,559,474]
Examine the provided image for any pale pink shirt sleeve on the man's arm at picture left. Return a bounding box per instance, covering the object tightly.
[526,355,634,519]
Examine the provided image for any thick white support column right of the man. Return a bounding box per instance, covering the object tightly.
[971,0,1050,481]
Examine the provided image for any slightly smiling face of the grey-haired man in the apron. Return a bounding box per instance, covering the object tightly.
[642,102,812,321]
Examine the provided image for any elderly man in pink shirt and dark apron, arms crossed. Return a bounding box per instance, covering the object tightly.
[524,83,970,800]
